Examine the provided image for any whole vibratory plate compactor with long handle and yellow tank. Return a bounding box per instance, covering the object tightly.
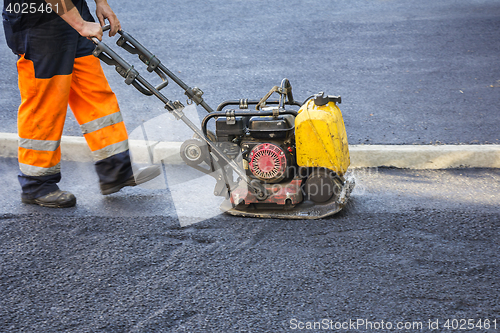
[93,26,354,219]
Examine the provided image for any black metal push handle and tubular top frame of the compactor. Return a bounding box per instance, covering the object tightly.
[92,24,302,200]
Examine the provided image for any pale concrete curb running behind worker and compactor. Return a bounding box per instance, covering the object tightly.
[0,133,500,169]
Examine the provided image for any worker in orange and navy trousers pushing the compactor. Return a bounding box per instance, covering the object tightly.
[2,0,160,208]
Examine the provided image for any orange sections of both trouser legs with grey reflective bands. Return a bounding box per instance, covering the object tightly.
[17,55,128,176]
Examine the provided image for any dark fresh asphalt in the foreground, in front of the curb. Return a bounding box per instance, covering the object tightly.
[0,159,500,332]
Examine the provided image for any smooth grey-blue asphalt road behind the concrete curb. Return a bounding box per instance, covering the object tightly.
[0,0,500,144]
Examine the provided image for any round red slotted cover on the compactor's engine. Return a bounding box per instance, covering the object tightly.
[248,143,288,183]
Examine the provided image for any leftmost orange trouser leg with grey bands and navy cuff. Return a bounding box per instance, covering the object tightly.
[17,55,71,199]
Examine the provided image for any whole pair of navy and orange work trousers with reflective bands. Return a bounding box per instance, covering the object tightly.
[3,0,132,199]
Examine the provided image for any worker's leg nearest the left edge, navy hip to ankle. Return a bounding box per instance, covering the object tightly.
[12,14,78,202]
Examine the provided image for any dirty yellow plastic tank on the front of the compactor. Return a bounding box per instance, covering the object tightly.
[295,94,351,176]
